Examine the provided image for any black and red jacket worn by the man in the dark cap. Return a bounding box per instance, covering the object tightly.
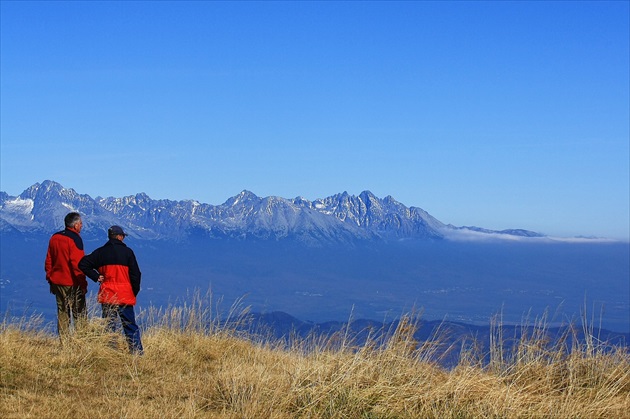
[79,239,141,305]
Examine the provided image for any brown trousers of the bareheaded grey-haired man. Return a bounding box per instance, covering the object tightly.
[50,284,87,338]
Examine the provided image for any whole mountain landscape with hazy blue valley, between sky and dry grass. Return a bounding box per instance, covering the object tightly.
[0,180,630,332]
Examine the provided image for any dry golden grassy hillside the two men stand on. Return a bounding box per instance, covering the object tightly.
[0,307,630,419]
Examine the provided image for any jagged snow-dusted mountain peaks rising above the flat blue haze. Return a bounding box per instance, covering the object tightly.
[0,180,541,244]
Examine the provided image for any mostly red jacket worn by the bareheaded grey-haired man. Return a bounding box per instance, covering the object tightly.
[44,229,87,291]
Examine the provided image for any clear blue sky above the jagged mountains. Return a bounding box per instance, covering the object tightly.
[0,1,630,239]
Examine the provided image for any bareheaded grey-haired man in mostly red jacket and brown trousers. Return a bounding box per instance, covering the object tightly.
[44,212,87,339]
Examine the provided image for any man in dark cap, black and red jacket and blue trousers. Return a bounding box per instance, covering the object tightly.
[79,226,143,354]
